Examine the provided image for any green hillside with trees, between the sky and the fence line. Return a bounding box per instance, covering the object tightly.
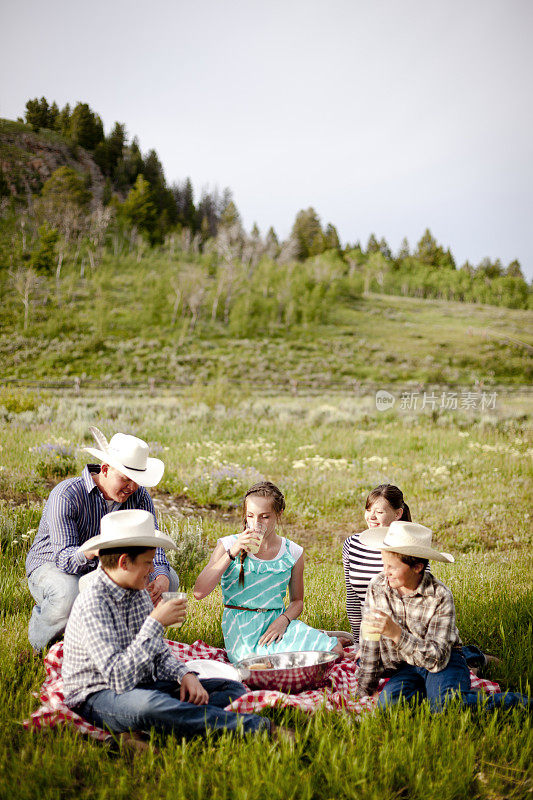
[0,98,533,393]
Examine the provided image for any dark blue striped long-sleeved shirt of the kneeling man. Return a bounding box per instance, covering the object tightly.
[26,464,170,580]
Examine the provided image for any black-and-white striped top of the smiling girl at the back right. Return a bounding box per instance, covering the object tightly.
[342,533,431,644]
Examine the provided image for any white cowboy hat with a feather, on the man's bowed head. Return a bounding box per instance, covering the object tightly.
[83,425,165,486]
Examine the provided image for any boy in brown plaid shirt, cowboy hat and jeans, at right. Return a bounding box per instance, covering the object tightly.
[358,520,531,711]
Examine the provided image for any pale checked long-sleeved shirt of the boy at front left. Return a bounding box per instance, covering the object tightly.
[62,570,190,708]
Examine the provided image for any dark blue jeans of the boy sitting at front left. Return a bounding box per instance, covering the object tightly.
[74,678,270,738]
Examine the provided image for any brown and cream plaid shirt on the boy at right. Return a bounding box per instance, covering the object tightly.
[359,572,461,695]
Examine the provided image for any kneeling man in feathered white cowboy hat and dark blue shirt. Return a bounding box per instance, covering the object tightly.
[26,427,179,651]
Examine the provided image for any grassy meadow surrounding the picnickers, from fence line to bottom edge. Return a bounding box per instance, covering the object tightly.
[0,383,533,800]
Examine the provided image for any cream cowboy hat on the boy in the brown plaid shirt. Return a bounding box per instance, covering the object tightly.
[359,519,455,563]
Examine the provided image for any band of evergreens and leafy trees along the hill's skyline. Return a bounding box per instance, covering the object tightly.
[0,97,531,322]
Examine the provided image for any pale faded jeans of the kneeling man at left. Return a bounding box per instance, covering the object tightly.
[28,562,180,650]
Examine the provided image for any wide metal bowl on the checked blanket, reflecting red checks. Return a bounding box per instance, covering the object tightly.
[236,650,339,692]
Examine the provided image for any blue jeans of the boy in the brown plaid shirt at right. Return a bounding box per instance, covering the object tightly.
[378,650,533,712]
